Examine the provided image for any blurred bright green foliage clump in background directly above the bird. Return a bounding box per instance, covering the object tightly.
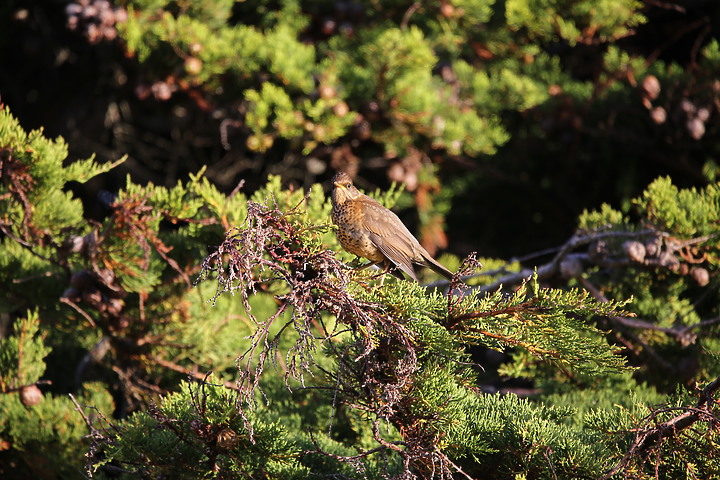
[332,24,507,156]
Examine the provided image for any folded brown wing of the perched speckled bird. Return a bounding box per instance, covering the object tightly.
[356,197,419,280]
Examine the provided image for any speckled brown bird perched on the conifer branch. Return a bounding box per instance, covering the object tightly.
[332,172,452,281]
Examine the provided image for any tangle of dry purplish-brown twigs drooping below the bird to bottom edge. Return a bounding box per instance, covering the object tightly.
[195,198,477,478]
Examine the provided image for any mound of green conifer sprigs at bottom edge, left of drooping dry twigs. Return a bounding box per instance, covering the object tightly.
[95,377,308,479]
